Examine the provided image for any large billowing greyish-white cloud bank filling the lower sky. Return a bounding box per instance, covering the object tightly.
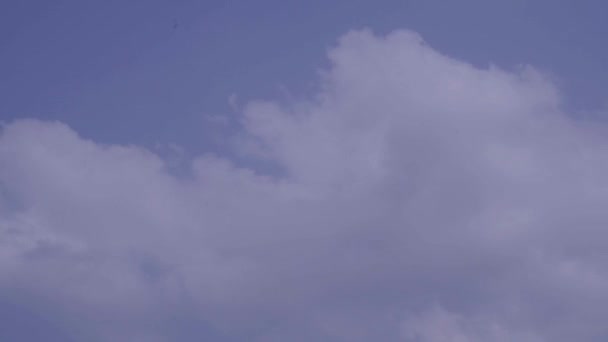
[0,30,608,342]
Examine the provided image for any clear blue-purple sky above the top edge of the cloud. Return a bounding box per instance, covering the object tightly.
[0,0,608,152]
